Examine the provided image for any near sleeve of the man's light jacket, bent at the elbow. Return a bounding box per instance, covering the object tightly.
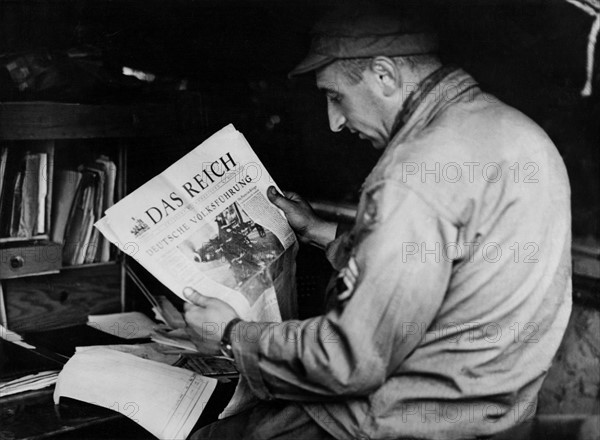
[233,182,457,401]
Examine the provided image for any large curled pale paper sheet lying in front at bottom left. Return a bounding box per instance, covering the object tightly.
[54,347,217,440]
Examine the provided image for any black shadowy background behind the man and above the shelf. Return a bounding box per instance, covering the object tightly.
[0,0,600,241]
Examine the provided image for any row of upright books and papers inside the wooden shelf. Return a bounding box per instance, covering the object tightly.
[0,147,117,266]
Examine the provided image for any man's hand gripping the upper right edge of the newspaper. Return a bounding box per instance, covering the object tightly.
[267,186,337,248]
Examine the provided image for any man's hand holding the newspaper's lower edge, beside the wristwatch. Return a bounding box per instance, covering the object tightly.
[183,287,238,355]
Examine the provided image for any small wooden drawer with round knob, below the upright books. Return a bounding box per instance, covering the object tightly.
[0,242,62,280]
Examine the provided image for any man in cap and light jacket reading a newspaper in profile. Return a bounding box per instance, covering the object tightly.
[185,4,571,439]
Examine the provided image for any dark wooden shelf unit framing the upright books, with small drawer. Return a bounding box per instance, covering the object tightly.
[0,96,208,330]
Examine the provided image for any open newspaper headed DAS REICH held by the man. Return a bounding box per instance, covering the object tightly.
[95,124,296,321]
